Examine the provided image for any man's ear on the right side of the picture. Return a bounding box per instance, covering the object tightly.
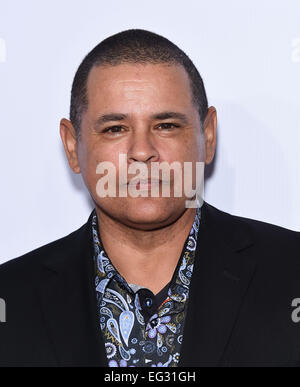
[203,106,217,164]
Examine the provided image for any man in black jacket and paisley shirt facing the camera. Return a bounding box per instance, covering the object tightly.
[0,30,300,367]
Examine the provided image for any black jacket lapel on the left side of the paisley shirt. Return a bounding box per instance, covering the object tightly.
[40,217,106,366]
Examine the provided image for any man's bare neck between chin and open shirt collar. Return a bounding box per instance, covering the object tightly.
[96,207,196,294]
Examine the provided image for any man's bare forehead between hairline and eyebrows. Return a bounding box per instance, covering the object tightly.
[87,63,192,110]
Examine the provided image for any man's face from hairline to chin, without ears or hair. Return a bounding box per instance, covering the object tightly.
[64,64,214,229]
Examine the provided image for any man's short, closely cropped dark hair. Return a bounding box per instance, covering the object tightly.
[70,29,208,135]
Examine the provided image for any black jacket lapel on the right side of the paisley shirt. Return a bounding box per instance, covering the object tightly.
[179,203,255,367]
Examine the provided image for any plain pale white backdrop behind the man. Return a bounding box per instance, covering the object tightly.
[0,0,300,263]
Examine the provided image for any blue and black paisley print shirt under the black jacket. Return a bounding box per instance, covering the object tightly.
[92,208,201,367]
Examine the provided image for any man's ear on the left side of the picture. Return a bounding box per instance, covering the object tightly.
[60,118,80,173]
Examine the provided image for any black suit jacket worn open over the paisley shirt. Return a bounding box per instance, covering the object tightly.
[0,203,300,366]
